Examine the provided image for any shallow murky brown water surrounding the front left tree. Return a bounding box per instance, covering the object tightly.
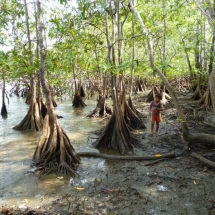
[0,96,106,207]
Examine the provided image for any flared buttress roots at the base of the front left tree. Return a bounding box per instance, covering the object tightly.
[33,115,80,175]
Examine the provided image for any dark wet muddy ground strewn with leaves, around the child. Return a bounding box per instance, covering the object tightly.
[2,95,215,215]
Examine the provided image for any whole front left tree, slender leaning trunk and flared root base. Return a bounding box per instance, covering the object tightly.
[33,1,80,175]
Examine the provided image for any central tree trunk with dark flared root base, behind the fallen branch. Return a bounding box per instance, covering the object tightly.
[93,0,134,154]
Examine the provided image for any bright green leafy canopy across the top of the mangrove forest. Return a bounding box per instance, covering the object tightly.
[0,0,211,86]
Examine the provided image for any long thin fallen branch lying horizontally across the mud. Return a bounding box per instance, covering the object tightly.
[77,152,175,161]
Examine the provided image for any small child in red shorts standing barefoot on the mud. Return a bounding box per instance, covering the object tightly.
[150,94,164,135]
